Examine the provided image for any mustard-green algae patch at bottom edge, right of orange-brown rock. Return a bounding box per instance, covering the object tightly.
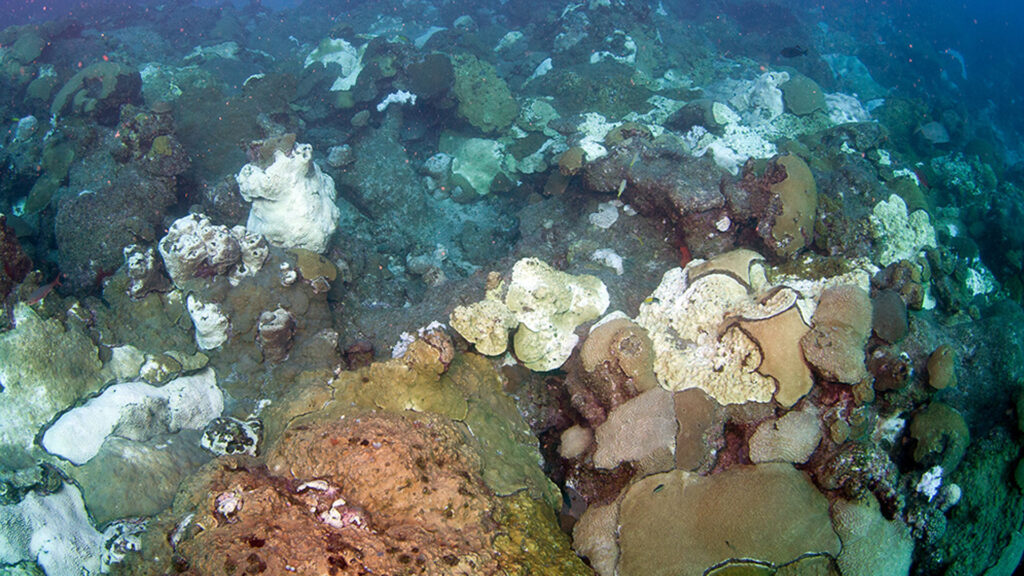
[493,492,593,576]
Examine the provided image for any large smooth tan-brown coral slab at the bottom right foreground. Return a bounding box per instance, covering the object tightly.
[616,464,840,576]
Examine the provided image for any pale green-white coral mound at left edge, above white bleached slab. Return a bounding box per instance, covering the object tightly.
[0,303,102,451]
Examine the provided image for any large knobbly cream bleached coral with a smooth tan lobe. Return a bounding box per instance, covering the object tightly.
[636,250,870,407]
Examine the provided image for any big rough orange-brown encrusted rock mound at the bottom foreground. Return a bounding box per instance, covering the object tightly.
[128,403,588,576]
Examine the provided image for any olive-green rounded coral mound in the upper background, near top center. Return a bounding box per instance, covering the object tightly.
[452,54,519,133]
